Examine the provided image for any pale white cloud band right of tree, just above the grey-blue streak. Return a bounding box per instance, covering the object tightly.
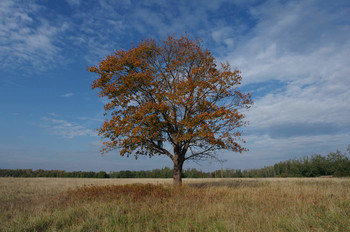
[247,79,350,129]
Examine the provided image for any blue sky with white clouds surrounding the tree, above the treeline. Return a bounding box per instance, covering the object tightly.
[0,0,350,171]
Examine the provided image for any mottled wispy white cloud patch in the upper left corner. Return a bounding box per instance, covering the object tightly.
[0,0,67,70]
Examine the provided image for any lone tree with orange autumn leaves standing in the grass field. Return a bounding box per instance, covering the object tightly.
[89,36,252,184]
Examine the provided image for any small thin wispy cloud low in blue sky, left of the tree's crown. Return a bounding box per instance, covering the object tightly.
[42,117,97,138]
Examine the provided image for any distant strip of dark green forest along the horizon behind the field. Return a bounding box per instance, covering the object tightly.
[0,146,350,178]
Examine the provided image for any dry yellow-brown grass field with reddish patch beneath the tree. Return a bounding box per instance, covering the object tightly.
[0,178,350,231]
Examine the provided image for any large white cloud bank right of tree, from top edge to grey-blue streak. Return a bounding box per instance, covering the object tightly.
[221,1,350,128]
